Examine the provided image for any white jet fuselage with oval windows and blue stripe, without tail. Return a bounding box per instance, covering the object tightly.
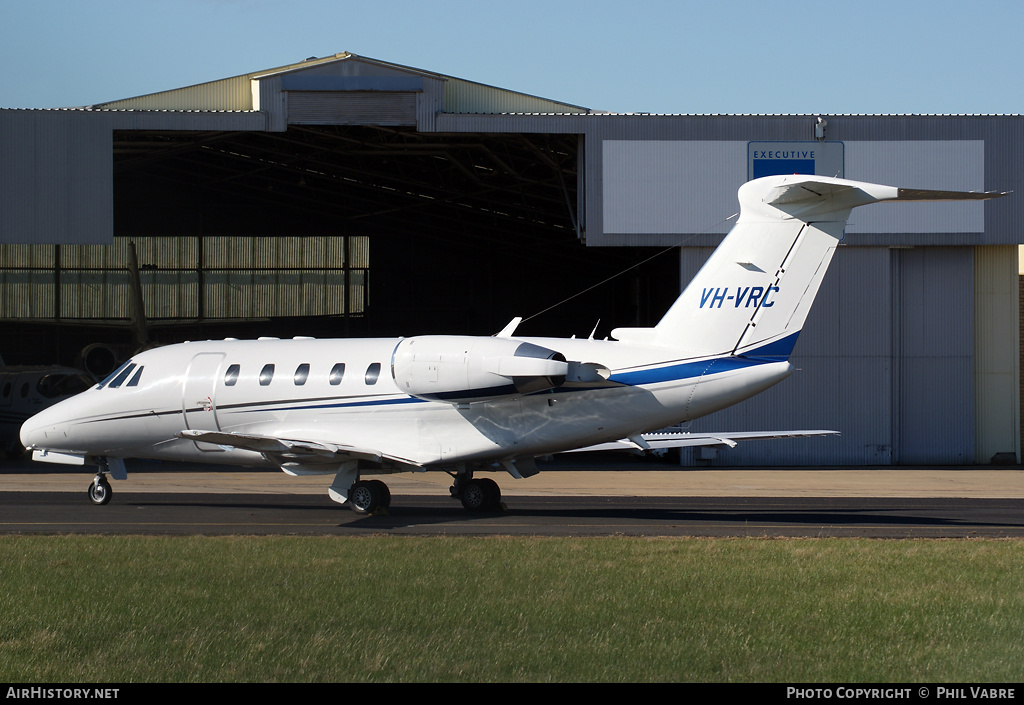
[22,336,791,469]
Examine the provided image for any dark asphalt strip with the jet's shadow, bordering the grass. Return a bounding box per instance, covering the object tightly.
[16,493,1024,534]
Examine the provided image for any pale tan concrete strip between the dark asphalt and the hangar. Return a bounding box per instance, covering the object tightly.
[0,462,1024,499]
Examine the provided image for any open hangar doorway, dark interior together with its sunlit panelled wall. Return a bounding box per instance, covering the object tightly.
[6,125,679,374]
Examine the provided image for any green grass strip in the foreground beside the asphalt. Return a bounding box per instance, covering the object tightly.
[0,536,1024,682]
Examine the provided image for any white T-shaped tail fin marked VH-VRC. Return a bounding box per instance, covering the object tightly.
[611,174,1004,359]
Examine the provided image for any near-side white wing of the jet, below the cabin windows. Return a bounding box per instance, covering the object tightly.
[176,430,420,474]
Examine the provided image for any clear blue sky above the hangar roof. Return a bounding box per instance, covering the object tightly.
[0,0,1024,114]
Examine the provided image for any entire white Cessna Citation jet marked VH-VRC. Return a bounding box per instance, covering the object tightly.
[20,175,1002,512]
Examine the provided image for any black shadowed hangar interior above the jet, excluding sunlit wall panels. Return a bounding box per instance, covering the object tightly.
[114,125,679,337]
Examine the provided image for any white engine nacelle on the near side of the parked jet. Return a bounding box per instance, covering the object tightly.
[391,335,569,404]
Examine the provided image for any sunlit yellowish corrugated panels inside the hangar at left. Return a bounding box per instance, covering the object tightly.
[0,236,370,320]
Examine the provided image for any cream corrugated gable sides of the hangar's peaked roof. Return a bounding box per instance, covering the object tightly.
[90,51,591,114]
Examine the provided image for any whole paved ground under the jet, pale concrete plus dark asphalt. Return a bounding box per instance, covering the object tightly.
[0,463,1024,538]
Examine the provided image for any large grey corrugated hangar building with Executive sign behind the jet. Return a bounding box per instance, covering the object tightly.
[0,53,1024,465]
